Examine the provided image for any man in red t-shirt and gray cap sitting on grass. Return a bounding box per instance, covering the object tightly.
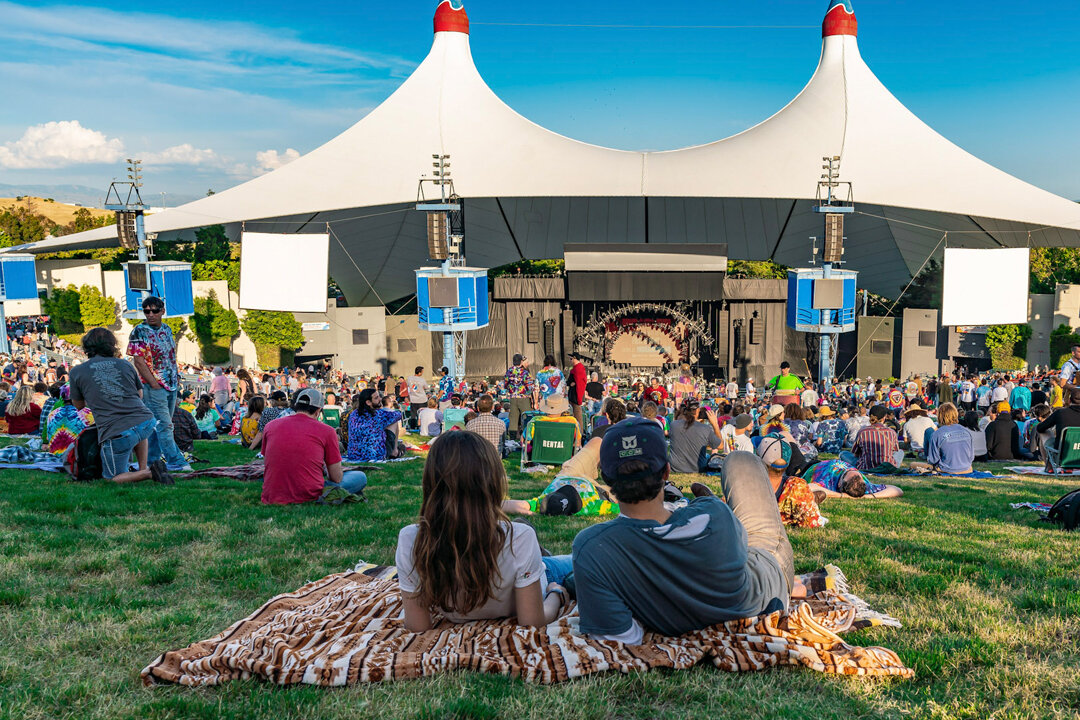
[262,388,367,505]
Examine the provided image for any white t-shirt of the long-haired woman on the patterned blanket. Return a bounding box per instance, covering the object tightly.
[394,522,548,623]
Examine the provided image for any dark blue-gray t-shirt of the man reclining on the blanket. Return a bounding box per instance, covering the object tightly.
[573,498,787,637]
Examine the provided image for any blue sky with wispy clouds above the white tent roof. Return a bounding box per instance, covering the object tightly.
[0,0,1080,204]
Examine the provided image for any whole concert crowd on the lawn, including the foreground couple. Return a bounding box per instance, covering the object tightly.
[10,310,1080,644]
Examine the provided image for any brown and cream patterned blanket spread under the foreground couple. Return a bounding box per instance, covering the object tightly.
[143,565,914,687]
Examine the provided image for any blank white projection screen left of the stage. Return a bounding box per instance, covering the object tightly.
[240,232,330,312]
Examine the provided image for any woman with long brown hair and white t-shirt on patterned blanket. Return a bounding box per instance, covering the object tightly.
[395,431,571,633]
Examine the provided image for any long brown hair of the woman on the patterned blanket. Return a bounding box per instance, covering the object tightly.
[413,431,509,615]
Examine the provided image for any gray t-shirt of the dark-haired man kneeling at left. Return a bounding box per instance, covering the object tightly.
[69,357,153,443]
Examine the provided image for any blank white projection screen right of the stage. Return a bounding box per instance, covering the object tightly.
[942,247,1030,326]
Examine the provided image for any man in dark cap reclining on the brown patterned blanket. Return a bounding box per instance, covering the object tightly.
[568,420,806,644]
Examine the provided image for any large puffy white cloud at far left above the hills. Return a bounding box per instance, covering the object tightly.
[0,120,124,169]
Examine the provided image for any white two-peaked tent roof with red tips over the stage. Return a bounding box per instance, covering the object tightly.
[17,0,1080,303]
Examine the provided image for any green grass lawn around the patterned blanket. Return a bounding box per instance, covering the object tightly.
[0,443,1080,720]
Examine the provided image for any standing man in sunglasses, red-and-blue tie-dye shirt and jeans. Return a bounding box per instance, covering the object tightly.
[127,295,191,473]
